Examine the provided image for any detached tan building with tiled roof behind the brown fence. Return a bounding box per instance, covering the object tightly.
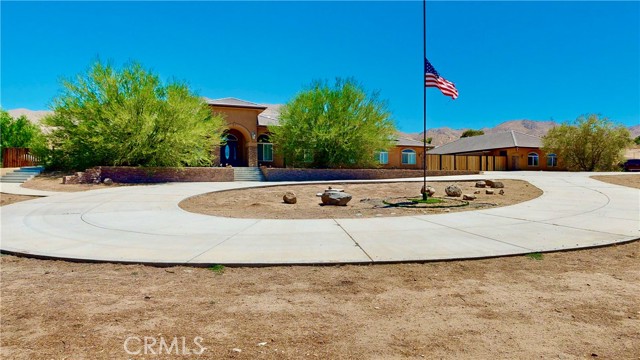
[427,130,564,170]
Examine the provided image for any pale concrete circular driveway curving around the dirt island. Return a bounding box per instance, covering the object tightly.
[0,172,640,265]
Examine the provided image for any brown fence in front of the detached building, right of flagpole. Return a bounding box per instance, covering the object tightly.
[427,154,507,171]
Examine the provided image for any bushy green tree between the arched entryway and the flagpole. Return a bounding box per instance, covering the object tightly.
[269,79,395,168]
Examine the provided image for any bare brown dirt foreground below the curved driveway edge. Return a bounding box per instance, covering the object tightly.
[0,241,640,359]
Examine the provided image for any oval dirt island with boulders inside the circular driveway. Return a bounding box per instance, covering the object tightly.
[179,180,542,219]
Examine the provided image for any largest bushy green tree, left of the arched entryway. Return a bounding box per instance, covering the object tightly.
[44,61,224,169]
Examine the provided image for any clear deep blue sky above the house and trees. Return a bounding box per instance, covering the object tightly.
[0,1,640,132]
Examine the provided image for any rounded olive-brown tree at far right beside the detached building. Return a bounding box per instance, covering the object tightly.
[542,114,631,171]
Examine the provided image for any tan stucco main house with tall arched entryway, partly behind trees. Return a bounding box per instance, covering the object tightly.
[205,98,433,169]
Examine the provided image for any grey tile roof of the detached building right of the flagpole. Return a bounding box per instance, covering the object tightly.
[428,130,542,155]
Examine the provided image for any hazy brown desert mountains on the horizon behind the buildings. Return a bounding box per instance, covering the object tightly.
[8,109,640,146]
